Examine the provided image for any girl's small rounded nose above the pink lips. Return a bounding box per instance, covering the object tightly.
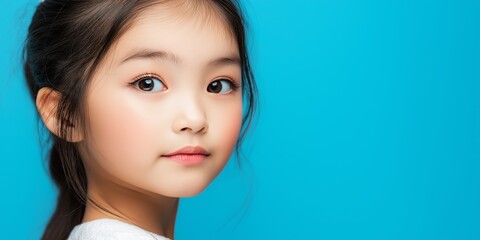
[173,95,208,134]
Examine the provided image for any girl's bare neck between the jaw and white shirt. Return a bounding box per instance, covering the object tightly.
[82,171,179,239]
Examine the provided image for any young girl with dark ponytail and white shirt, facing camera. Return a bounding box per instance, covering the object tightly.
[24,0,257,240]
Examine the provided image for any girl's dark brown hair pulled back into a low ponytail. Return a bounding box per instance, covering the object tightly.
[22,0,258,240]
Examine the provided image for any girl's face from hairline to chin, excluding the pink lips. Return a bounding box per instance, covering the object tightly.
[81,5,242,197]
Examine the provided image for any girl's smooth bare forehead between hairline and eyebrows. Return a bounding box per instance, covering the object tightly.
[106,1,239,65]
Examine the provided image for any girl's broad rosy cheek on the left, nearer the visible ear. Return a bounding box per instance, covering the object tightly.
[88,88,162,178]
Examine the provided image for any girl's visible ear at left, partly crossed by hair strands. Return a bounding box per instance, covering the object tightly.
[36,87,83,142]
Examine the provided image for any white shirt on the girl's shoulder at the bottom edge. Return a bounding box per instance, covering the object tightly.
[67,218,171,240]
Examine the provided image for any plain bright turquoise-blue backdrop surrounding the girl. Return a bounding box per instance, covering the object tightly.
[0,0,480,239]
